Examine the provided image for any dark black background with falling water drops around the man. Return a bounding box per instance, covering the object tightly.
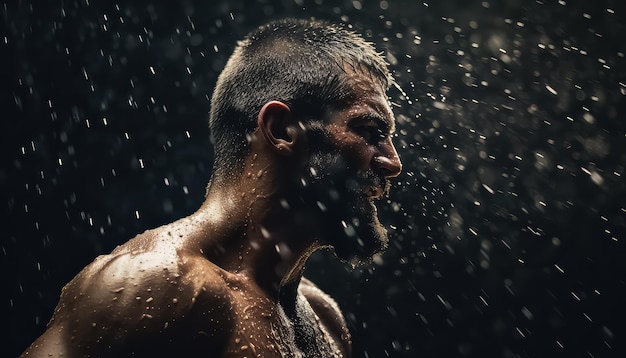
[0,0,626,357]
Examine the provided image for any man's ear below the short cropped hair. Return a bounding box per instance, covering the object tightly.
[258,101,296,155]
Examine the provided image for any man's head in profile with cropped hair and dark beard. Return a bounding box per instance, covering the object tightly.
[210,19,401,263]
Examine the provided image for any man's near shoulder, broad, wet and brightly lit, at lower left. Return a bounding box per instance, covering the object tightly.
[26,231,230,356]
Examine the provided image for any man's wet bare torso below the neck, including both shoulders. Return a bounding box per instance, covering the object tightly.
[25,215,349,357]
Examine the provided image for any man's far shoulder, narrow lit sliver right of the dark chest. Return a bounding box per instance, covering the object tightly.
[299,277,352,356]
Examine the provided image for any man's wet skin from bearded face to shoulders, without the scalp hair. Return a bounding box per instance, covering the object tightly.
[24,74,401,357]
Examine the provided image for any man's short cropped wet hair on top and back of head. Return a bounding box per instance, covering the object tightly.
[209,18,392,180]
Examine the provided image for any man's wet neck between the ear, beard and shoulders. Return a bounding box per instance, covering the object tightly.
[186,157,320,300]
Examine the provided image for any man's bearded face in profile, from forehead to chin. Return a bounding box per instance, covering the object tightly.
[303,74,402,265]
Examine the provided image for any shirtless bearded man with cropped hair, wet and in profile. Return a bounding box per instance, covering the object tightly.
[23,19,401,357]
